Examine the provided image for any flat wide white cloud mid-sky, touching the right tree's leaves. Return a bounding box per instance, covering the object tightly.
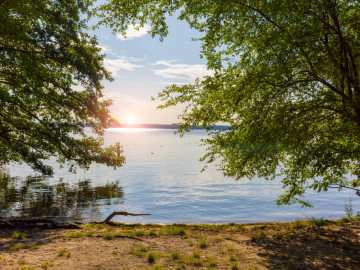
[152,60,214,81]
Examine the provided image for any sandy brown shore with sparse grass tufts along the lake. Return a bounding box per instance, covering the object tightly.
[0,219,360,270]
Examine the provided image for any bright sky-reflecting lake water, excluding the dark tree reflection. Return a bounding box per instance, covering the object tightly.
[4,128,360,224]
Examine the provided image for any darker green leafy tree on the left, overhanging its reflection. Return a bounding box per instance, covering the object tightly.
[0,0,124,175]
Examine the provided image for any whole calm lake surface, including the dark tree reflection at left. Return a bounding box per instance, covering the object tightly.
[0,129,360,224]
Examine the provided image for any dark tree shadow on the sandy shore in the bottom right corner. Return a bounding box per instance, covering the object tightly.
[249,221,360,269]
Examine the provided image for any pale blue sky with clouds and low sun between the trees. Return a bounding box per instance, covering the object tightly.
[94,14,211,124]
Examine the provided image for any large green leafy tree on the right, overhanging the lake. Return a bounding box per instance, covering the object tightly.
[97,0,360,206]
